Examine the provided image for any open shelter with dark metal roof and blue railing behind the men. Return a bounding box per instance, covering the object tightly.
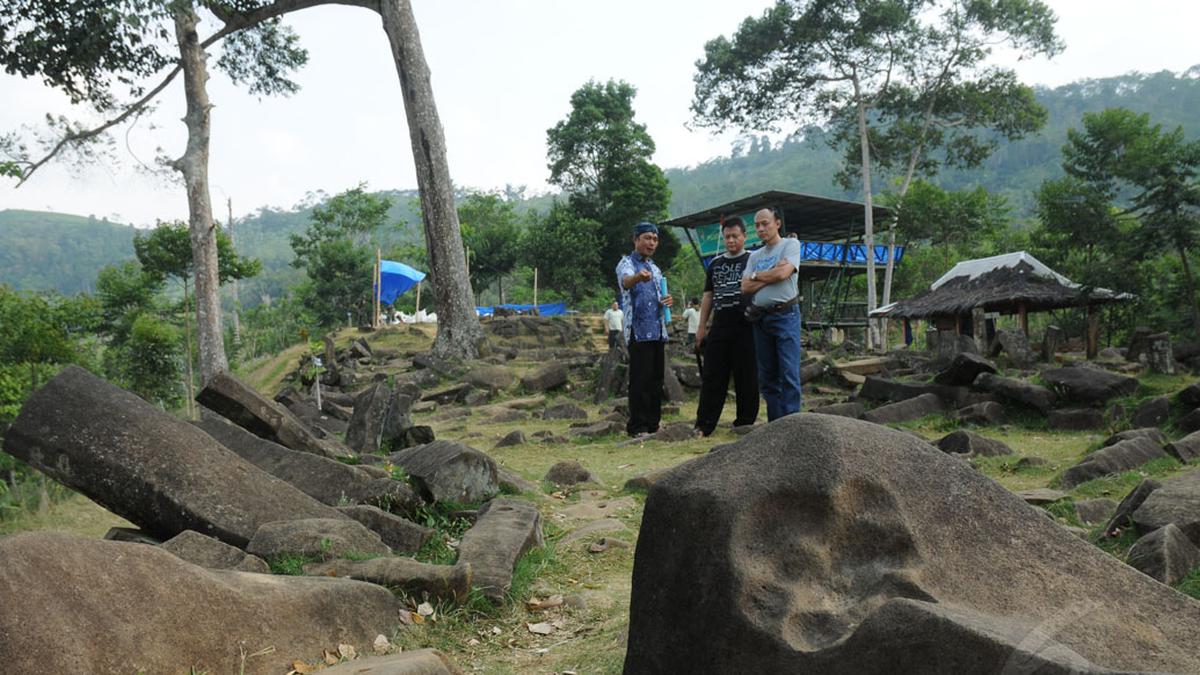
[661,190,904,328]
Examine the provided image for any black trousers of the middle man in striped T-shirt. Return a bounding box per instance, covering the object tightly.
[696,319,758,435]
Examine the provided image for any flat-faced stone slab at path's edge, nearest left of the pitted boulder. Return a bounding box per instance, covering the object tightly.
[458,498,542,602]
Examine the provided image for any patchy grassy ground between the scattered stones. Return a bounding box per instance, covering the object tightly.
[0,325,1200,674]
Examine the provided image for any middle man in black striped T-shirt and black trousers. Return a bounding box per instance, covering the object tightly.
[695,216,758,436]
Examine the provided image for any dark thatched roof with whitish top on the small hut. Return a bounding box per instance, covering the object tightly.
[872,251,1132,318]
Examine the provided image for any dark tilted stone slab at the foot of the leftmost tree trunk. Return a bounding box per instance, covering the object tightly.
[196,372,354,459]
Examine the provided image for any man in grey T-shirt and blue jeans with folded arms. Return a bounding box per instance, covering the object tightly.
[742,209,800,422]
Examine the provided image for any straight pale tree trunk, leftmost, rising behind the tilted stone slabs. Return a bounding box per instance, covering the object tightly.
[172,2,229,384]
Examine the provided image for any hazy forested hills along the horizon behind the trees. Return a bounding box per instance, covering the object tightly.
[0,66,1200,294]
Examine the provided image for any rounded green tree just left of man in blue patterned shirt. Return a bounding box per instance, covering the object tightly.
[522,201,604,303]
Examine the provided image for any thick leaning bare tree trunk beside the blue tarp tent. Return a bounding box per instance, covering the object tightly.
[379,0,484,359]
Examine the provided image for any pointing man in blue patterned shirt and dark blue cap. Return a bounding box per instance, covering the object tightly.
[617,221,671,437]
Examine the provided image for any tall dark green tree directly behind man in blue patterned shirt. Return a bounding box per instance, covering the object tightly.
[546,80,679,283]
